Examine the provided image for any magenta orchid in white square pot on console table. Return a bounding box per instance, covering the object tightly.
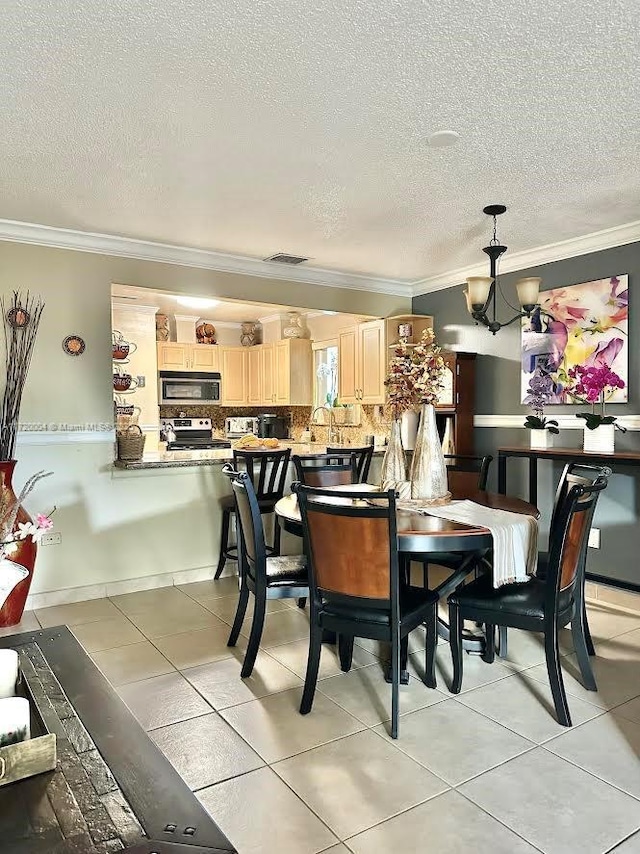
[568,365,626,454]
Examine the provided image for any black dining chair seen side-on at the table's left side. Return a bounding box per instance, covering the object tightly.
[222,464,309,679]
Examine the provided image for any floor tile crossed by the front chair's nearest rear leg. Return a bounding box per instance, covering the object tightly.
[316,662,447,726]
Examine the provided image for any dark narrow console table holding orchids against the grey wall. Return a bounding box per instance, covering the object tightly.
[498,447,640,593]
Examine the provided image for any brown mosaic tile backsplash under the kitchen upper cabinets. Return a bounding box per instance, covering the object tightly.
[160,406,389,445]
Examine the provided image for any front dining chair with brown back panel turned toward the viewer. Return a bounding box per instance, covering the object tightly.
[295,483,438,738]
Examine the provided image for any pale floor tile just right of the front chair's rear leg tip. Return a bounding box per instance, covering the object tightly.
[375,700,535,786]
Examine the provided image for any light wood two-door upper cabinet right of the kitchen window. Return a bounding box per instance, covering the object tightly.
[338,320,386,403]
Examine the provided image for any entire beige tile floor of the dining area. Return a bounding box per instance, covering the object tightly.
[3,577,640,854]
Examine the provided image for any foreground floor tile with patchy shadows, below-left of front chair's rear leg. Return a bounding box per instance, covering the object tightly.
[273,730,448,840]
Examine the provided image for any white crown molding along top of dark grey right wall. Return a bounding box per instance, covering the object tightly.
[411,220,640,297]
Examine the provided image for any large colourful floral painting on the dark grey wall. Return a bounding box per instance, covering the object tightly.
[521,276,629,403]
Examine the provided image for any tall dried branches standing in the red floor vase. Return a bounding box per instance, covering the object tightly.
[0,291,44,460]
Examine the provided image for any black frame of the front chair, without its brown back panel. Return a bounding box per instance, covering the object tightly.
[293,483,438,738]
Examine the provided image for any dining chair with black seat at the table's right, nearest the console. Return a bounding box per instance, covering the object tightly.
[448,469,610,726]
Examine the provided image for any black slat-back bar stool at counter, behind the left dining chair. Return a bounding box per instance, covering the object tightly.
[218,448,291,580]
